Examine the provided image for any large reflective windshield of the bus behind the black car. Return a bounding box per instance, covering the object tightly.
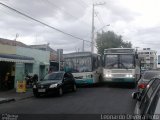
[65,57,92,73]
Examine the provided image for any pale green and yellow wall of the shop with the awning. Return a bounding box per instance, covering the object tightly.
[0,44,50,87]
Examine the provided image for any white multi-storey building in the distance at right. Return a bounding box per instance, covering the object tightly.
[138,48,157,69]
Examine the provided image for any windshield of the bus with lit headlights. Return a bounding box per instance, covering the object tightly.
[105,54,134,69]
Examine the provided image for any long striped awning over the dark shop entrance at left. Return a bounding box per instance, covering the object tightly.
[0,54,35,63]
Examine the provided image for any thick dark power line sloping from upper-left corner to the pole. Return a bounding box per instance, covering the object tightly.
[0,2,93,44]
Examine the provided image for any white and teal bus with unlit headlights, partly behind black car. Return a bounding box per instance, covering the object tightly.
[63,52,102,84]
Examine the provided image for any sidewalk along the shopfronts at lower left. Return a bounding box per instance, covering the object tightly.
[0,89,33,104]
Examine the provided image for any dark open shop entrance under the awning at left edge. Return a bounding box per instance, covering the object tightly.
[0,61,15,90]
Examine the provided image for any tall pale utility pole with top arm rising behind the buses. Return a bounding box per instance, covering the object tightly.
[91,3,105,53]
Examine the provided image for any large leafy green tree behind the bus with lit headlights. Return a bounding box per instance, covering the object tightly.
[96,31,132,54]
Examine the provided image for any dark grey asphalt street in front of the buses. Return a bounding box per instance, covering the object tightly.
[0,86,135,114]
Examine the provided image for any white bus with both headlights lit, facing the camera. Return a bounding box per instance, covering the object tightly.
[102,48,140,86]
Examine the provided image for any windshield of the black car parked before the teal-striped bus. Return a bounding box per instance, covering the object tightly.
[43,73,63,80]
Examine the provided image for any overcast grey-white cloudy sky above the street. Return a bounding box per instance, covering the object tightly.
[0,0,160,54]
